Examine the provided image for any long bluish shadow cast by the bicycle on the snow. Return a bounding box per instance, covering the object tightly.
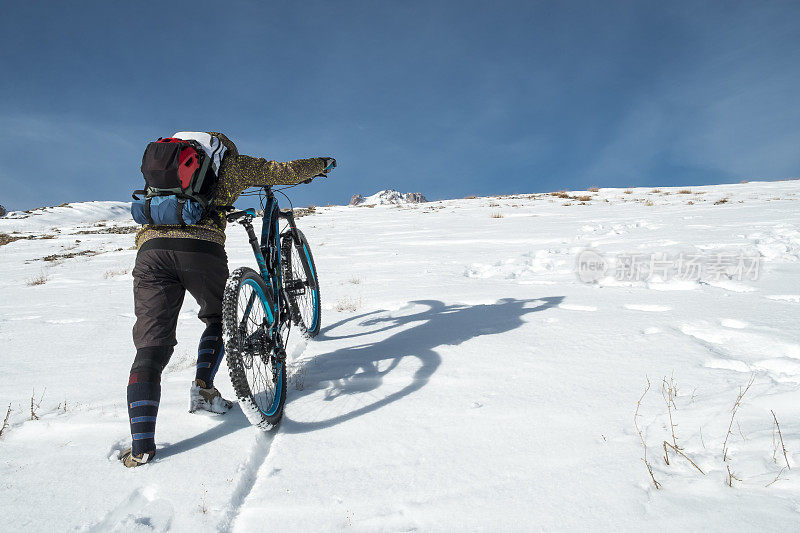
[281,296,564,433]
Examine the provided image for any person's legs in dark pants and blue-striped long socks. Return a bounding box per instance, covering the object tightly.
[127,238,228,454]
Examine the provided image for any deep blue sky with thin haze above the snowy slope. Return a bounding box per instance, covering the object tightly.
[0,0,800,209]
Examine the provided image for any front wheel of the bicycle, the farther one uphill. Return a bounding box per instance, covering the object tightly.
[281,230,322,338]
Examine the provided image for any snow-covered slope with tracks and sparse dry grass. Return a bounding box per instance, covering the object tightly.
[0,181,800,531]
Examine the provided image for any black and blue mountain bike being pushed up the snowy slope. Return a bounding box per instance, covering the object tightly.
[222,176,321,431]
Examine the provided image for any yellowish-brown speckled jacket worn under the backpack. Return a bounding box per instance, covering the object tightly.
[136,131,325,248]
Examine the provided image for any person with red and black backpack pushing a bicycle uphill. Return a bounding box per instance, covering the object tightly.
[120,132,336,468]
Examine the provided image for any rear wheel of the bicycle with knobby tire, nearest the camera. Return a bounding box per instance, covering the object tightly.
[222,267,286,431]
